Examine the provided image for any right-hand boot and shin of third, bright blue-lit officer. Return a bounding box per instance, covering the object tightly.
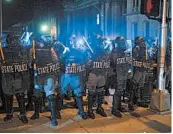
[75,96,87,119]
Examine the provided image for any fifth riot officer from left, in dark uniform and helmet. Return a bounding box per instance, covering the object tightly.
[111,37,132,117]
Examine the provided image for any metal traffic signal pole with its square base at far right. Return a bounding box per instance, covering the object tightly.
[150,0,170,114]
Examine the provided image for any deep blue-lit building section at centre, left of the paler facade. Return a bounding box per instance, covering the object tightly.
[64,0,126,39]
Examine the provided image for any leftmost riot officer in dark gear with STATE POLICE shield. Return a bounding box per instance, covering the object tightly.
[1,35,29,123]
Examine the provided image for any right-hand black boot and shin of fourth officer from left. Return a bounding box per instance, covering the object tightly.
[96,91,107,117]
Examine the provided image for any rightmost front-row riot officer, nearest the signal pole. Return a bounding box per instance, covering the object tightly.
[129,36,148,110]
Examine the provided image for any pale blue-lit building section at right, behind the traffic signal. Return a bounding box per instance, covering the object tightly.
[124,0,171,40]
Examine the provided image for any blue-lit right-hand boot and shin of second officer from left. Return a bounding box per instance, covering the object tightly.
[48,95,58,127]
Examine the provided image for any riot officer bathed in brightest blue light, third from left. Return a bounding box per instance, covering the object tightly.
[61,34,87,119]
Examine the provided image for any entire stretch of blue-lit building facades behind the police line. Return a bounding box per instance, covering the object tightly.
[64,0,171,40]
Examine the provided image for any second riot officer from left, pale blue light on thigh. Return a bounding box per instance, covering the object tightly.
[30,38,60,126]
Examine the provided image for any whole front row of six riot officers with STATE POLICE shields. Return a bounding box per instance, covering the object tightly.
[1,30,170,126]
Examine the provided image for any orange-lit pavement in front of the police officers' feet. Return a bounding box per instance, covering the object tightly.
[0,97,171,133]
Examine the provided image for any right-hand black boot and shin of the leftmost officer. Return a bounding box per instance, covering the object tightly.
[16,93,28,124]
